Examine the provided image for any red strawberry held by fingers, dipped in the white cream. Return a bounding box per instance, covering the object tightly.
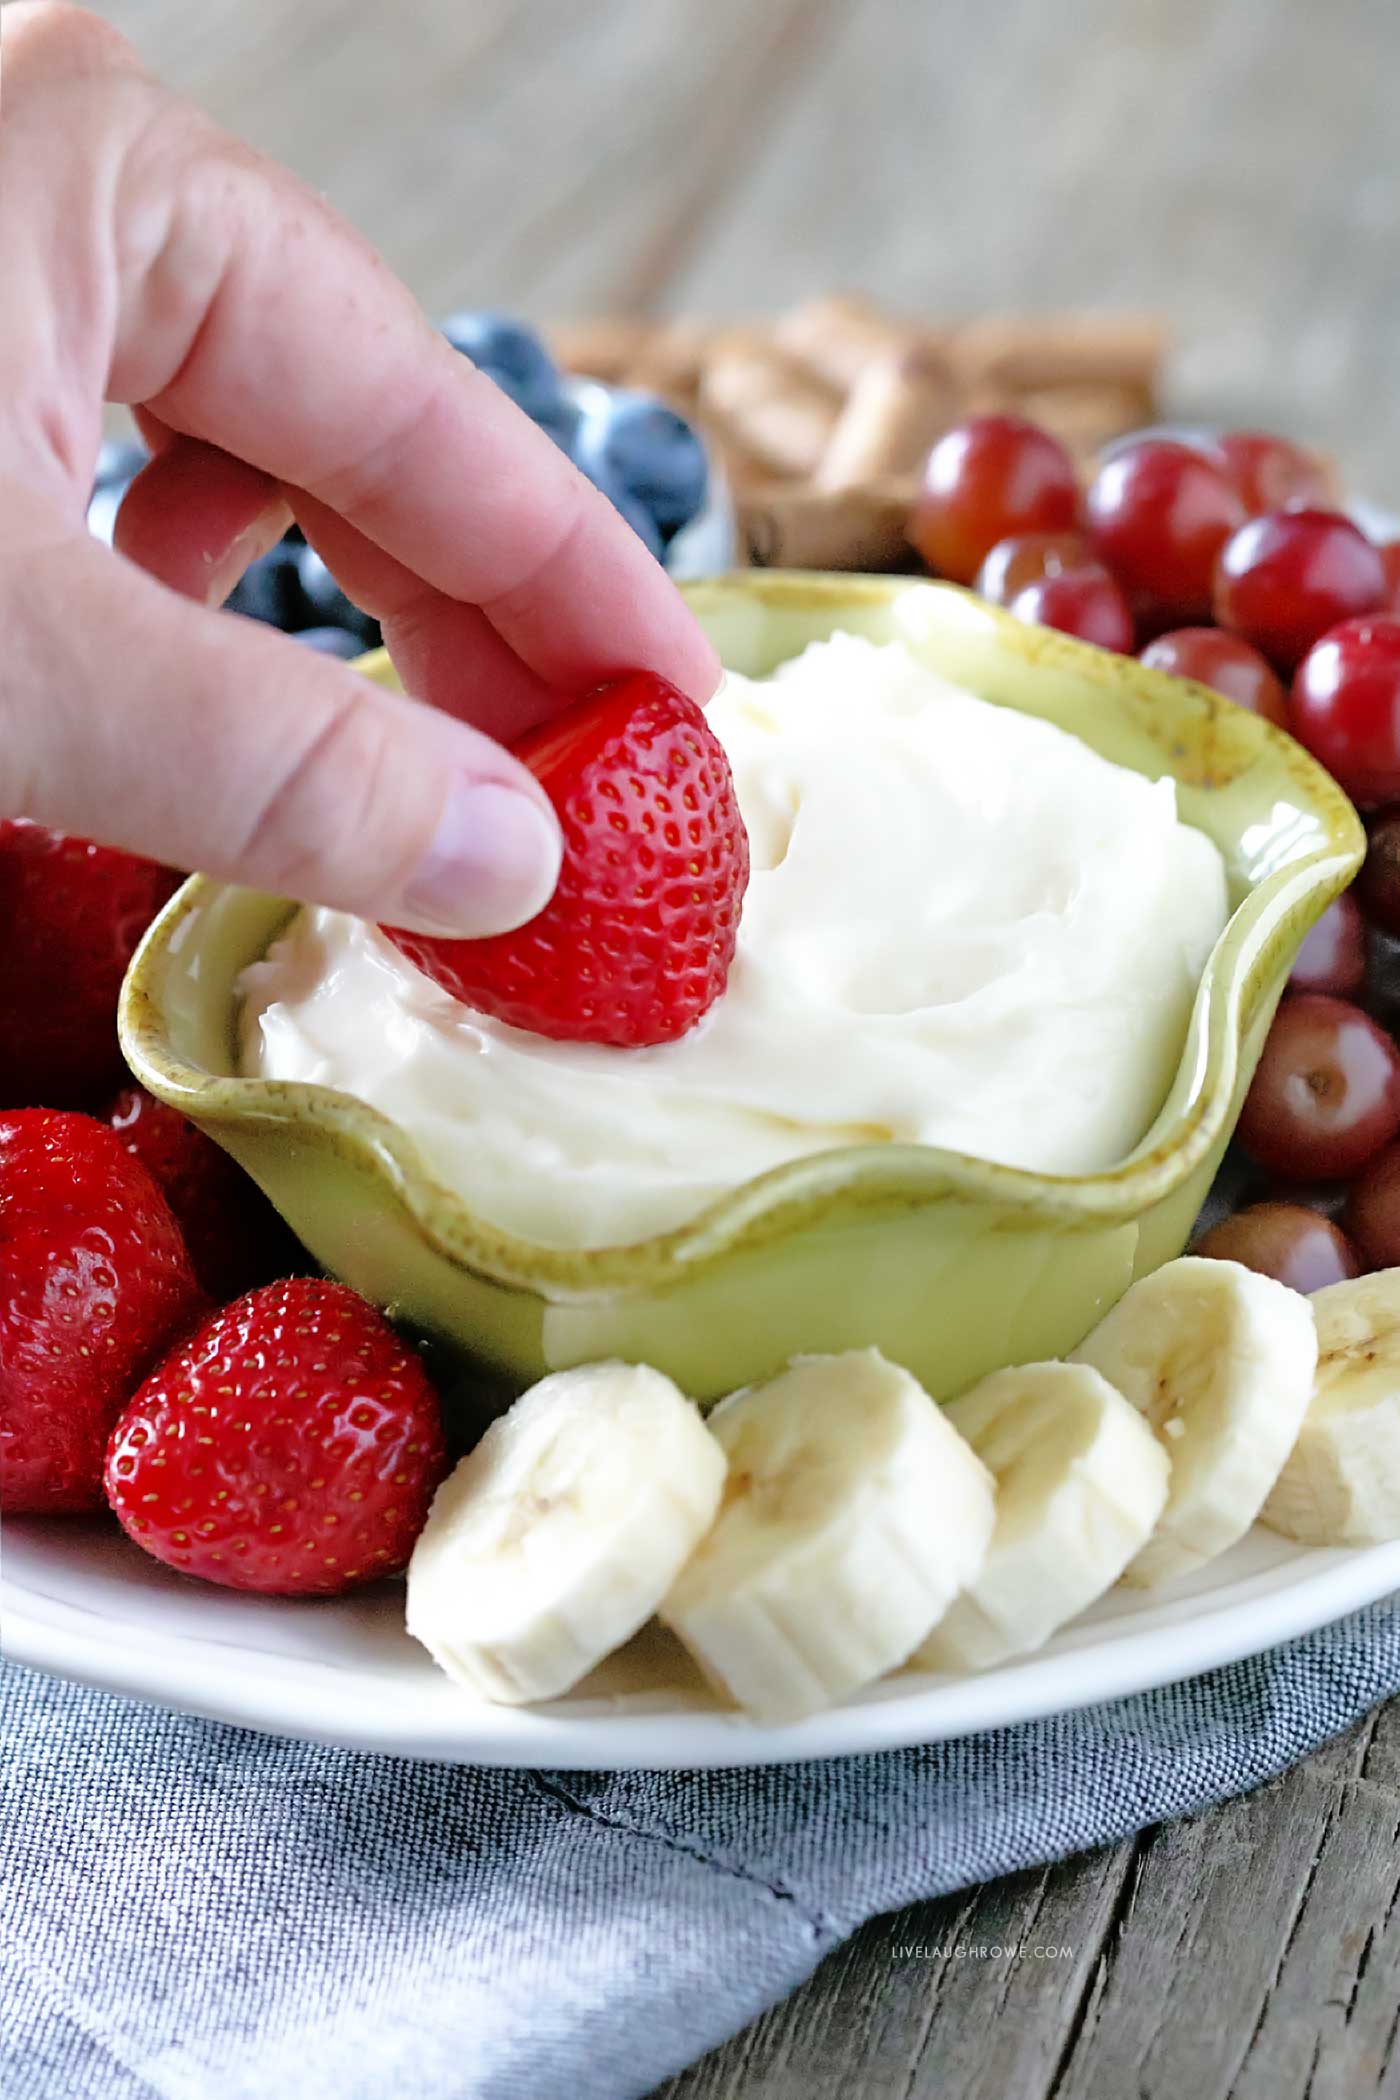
[386,672,749,1048]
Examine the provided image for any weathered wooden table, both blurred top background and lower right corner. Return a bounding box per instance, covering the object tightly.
[92,0,1400,2100]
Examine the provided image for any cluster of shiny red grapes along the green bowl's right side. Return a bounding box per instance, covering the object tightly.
[909,416,1400,1292]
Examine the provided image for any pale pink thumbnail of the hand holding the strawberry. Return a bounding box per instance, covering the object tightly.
[403,779,563,941]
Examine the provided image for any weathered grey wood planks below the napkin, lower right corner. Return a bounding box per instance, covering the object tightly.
[657,1707,1400,2100]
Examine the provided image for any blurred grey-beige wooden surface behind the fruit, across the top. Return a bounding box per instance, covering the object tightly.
[99,0,1400,487]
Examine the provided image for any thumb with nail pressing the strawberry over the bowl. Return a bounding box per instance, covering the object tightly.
[0,516,560,937]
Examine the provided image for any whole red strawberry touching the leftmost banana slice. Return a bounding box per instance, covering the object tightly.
[107,1277,447,1596]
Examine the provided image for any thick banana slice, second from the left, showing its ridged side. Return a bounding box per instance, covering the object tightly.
[661,1348,993,1722]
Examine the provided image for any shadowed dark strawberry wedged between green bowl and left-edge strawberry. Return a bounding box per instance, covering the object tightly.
[103,1086,304,1304]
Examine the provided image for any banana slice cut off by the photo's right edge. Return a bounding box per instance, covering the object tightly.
[1264,1268,1400,1546]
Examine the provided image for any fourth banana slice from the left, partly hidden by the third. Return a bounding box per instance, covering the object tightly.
[1070,1256,1318,1588]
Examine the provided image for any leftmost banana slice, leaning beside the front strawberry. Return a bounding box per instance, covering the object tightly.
[407,1363,724,1703]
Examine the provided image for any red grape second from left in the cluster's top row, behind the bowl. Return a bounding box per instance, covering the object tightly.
[1085,437,1245,626]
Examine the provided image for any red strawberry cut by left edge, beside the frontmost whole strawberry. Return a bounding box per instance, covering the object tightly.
[0,1109,204,1516]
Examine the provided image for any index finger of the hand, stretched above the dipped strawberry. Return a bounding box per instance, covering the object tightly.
[6,12,718,699]
